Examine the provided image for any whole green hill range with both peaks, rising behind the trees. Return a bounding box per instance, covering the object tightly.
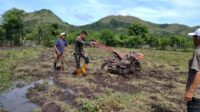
[19,9,199,35]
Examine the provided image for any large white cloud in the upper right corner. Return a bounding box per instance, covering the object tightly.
[111,0,200,26]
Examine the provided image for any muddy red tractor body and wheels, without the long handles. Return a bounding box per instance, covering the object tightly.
[101,52,143,77]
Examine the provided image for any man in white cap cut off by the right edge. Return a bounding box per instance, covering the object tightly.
[185,28,200,112]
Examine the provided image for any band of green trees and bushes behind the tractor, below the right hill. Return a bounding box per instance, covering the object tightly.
[83,24,193,51]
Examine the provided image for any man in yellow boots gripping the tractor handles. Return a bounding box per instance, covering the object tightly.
[74,31,96,76]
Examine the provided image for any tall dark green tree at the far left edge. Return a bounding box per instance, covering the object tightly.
[2,8,25,45]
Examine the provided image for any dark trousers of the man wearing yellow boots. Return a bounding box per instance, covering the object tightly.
[74,53,89,68]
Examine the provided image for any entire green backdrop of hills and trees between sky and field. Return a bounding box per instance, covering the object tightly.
[0,8,196,51]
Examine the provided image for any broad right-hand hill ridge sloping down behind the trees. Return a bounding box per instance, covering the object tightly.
[81,16,196,35]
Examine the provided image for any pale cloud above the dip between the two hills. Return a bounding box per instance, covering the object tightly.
[70,0,118,25]
